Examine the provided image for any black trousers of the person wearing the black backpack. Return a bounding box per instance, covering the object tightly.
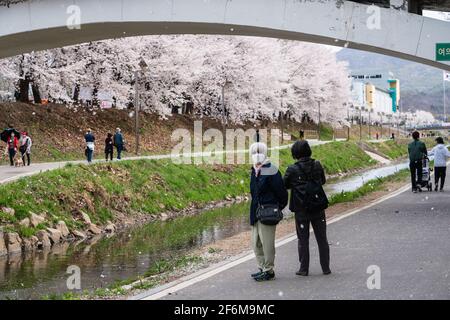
[295,215,330,272]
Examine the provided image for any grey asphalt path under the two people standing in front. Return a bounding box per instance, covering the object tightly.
[146,182,450,300]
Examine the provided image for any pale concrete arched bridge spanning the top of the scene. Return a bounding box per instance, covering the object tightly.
[0,0,450,71]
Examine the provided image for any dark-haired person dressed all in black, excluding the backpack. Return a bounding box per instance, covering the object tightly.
[284,140,331,276]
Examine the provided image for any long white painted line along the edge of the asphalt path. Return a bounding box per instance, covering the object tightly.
[136,184,410,300]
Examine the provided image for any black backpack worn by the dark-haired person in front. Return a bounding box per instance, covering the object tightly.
[296,161,329,213]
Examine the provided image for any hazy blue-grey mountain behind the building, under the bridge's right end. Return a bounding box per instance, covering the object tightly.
[336,48,450,115]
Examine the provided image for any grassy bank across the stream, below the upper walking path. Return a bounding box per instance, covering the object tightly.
[0,142,375,237]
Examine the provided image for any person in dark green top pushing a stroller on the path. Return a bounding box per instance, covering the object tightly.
[408,131,427,193]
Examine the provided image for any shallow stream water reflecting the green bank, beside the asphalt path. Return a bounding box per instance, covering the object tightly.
[0,164,407,299]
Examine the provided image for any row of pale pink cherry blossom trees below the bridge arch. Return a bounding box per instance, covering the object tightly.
[0,35,350,124]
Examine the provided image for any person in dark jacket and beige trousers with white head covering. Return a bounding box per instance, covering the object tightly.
[250,142,288,281]
